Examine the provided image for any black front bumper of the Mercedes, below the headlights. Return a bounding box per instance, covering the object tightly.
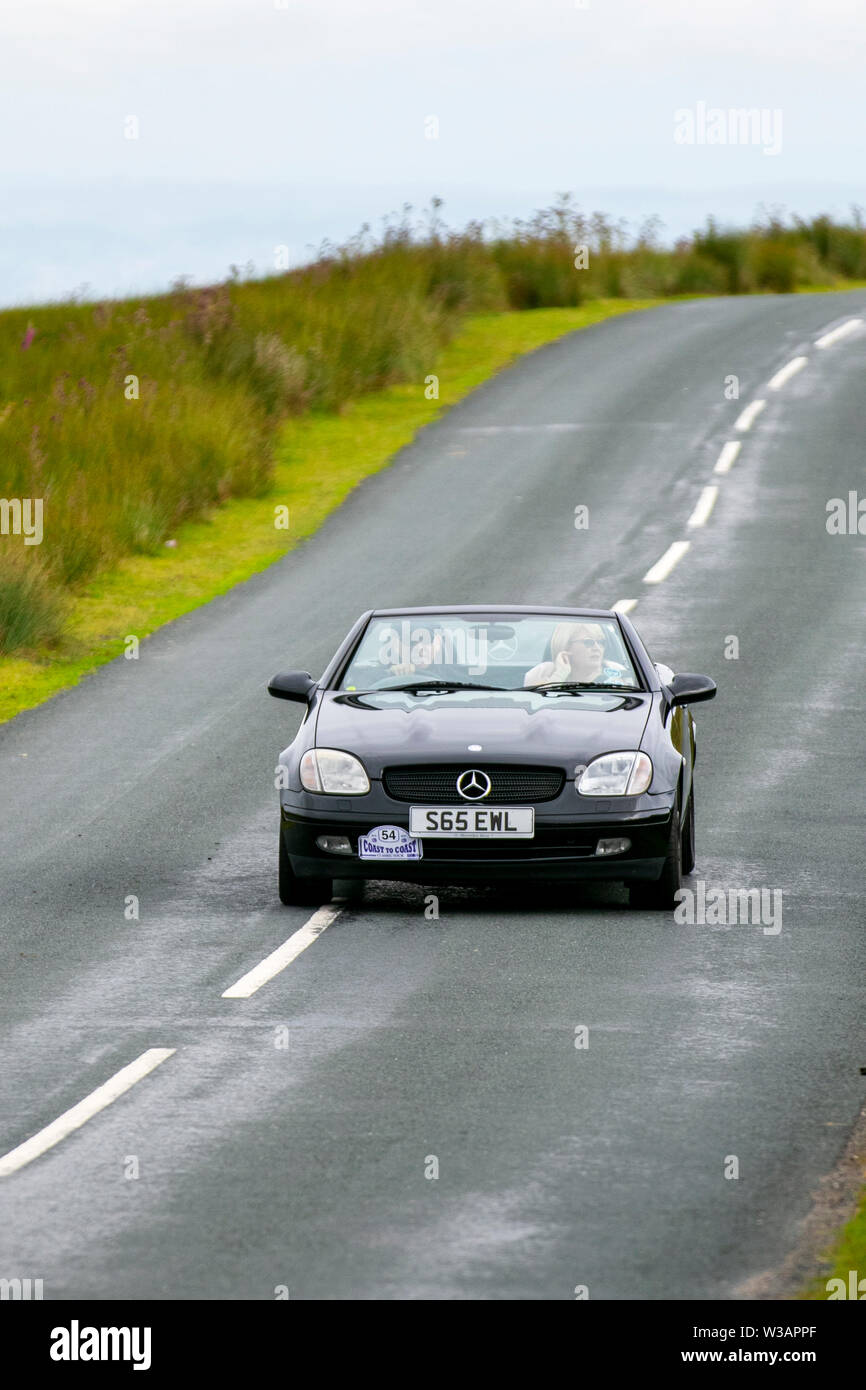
[281,794,676,883]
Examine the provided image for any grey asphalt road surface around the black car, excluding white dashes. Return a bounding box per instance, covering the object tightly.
[0,293,866,1300]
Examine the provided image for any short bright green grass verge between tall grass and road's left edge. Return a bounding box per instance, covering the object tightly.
[0,299,657,720]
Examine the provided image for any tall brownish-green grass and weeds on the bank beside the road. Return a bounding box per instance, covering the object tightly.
[0,197,866,653]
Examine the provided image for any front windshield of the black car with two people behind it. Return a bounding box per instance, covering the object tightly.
[339,613,641,691]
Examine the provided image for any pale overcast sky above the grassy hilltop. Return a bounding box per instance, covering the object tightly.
[0,0,866,303]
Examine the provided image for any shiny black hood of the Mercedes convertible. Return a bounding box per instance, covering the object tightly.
[316,691,652,777]
